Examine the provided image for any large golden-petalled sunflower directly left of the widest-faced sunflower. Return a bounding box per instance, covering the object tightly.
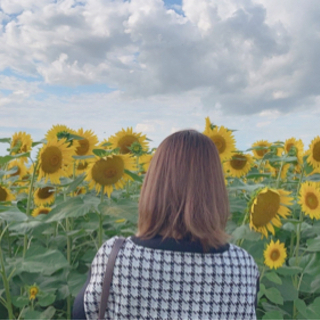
[38,138,74,184]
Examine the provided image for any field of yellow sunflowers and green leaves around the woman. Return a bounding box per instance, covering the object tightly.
[0,118,320,319]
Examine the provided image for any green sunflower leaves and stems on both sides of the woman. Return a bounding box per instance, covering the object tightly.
[0,132,320,320]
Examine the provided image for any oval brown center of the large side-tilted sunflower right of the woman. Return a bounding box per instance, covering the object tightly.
[252,190,280,228]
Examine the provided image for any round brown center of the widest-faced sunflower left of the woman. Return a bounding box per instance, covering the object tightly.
[91,156,124,186]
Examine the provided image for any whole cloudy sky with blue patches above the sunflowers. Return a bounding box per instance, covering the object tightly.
[0,0,320,155]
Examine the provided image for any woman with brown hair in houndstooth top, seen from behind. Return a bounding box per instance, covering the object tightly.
[73,130,259,320]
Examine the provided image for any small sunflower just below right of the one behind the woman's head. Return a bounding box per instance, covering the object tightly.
[223,152,253,178]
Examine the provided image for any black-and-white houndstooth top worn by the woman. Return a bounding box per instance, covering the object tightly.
[84,237,259,320]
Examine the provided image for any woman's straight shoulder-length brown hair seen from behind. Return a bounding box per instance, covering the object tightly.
[137,130,229,251]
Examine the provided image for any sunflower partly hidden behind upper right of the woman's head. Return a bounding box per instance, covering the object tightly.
[203,117,236,161]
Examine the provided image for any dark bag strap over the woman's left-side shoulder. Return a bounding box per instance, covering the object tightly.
[99,237,126,320]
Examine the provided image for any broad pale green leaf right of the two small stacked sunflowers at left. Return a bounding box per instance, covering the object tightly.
[45,197,92,223]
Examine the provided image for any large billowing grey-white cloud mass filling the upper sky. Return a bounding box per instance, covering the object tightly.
[0,0,320,114]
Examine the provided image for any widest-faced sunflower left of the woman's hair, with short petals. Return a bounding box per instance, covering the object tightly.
[85,155,136,197]
